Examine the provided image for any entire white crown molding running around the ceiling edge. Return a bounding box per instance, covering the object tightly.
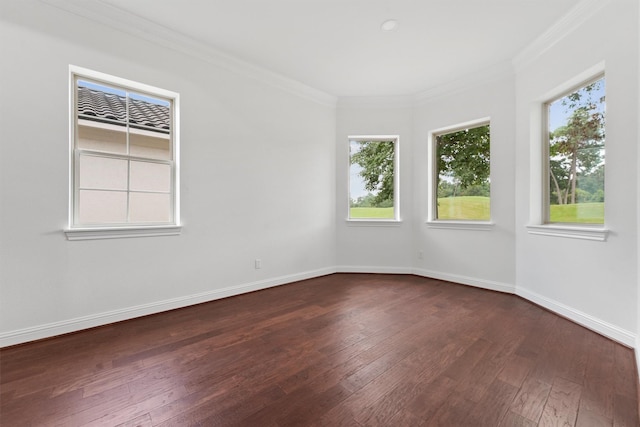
[40,0,612,108]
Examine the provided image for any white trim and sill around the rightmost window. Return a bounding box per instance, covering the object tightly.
[526,61,610,242]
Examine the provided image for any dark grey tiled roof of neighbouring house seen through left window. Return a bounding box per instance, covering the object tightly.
[77,86,171,133]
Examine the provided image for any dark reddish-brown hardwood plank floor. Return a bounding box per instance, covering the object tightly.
[0,274,640,427]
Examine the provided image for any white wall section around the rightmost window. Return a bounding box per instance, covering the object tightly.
[515,0,638,345]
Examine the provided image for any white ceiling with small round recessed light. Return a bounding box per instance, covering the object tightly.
[96,0,580,96]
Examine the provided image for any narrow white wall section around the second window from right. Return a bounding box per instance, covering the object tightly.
[413,74,515,292]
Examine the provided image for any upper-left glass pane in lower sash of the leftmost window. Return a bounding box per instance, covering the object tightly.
[80,155,127,190]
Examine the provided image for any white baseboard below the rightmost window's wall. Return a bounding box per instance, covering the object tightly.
[516,287,638,350]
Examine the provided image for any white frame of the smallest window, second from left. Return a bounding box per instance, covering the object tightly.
[347,135,402,226]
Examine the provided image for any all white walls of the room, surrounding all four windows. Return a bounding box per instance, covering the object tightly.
[0,0,640,354]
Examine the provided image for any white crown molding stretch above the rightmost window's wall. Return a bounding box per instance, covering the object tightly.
[512,0,611,72]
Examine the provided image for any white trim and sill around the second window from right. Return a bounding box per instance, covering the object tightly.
[425,117,495,231]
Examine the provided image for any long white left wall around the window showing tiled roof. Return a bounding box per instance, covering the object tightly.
[0,0,336,345]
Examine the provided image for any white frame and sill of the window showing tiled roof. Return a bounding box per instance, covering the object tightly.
[64,65,182,240]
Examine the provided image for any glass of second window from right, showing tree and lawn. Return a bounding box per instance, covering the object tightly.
[432,122,491,221]
